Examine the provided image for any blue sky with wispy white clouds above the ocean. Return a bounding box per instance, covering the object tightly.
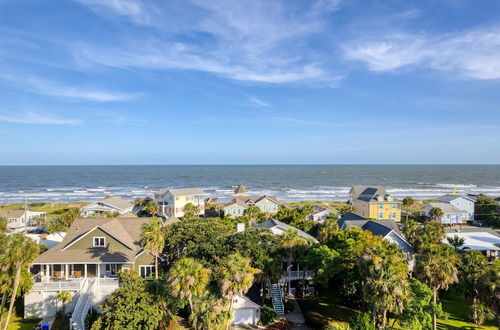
[0,0,500,165]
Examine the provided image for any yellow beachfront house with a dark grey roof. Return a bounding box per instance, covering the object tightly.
[353,187,401,221]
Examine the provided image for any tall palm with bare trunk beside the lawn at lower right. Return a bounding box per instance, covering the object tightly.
[414,244,459,330]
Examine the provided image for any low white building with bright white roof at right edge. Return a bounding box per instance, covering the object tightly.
[443,228,500,261]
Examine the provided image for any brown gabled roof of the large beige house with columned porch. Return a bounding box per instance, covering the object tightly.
[33,218,150,264]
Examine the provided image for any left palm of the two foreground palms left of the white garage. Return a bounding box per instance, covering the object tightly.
[167,258,210,312]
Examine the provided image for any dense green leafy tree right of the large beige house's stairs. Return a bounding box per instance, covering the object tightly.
[92,271,162,330]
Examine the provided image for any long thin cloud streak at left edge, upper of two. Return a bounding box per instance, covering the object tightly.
[0,73,139,102]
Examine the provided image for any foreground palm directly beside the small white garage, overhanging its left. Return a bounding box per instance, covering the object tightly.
[216,253,260,328]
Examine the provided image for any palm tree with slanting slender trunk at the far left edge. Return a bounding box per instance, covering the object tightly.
[0,234,39,330]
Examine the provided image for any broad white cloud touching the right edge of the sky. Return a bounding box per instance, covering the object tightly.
[344,26,500,80]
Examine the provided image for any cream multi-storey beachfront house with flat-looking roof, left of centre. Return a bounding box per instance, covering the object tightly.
[155,188,205,218]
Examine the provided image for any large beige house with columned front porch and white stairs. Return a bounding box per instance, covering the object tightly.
[24,218,154,328]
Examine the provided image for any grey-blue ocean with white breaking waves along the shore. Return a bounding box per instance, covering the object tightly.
[0,165,500,203]
